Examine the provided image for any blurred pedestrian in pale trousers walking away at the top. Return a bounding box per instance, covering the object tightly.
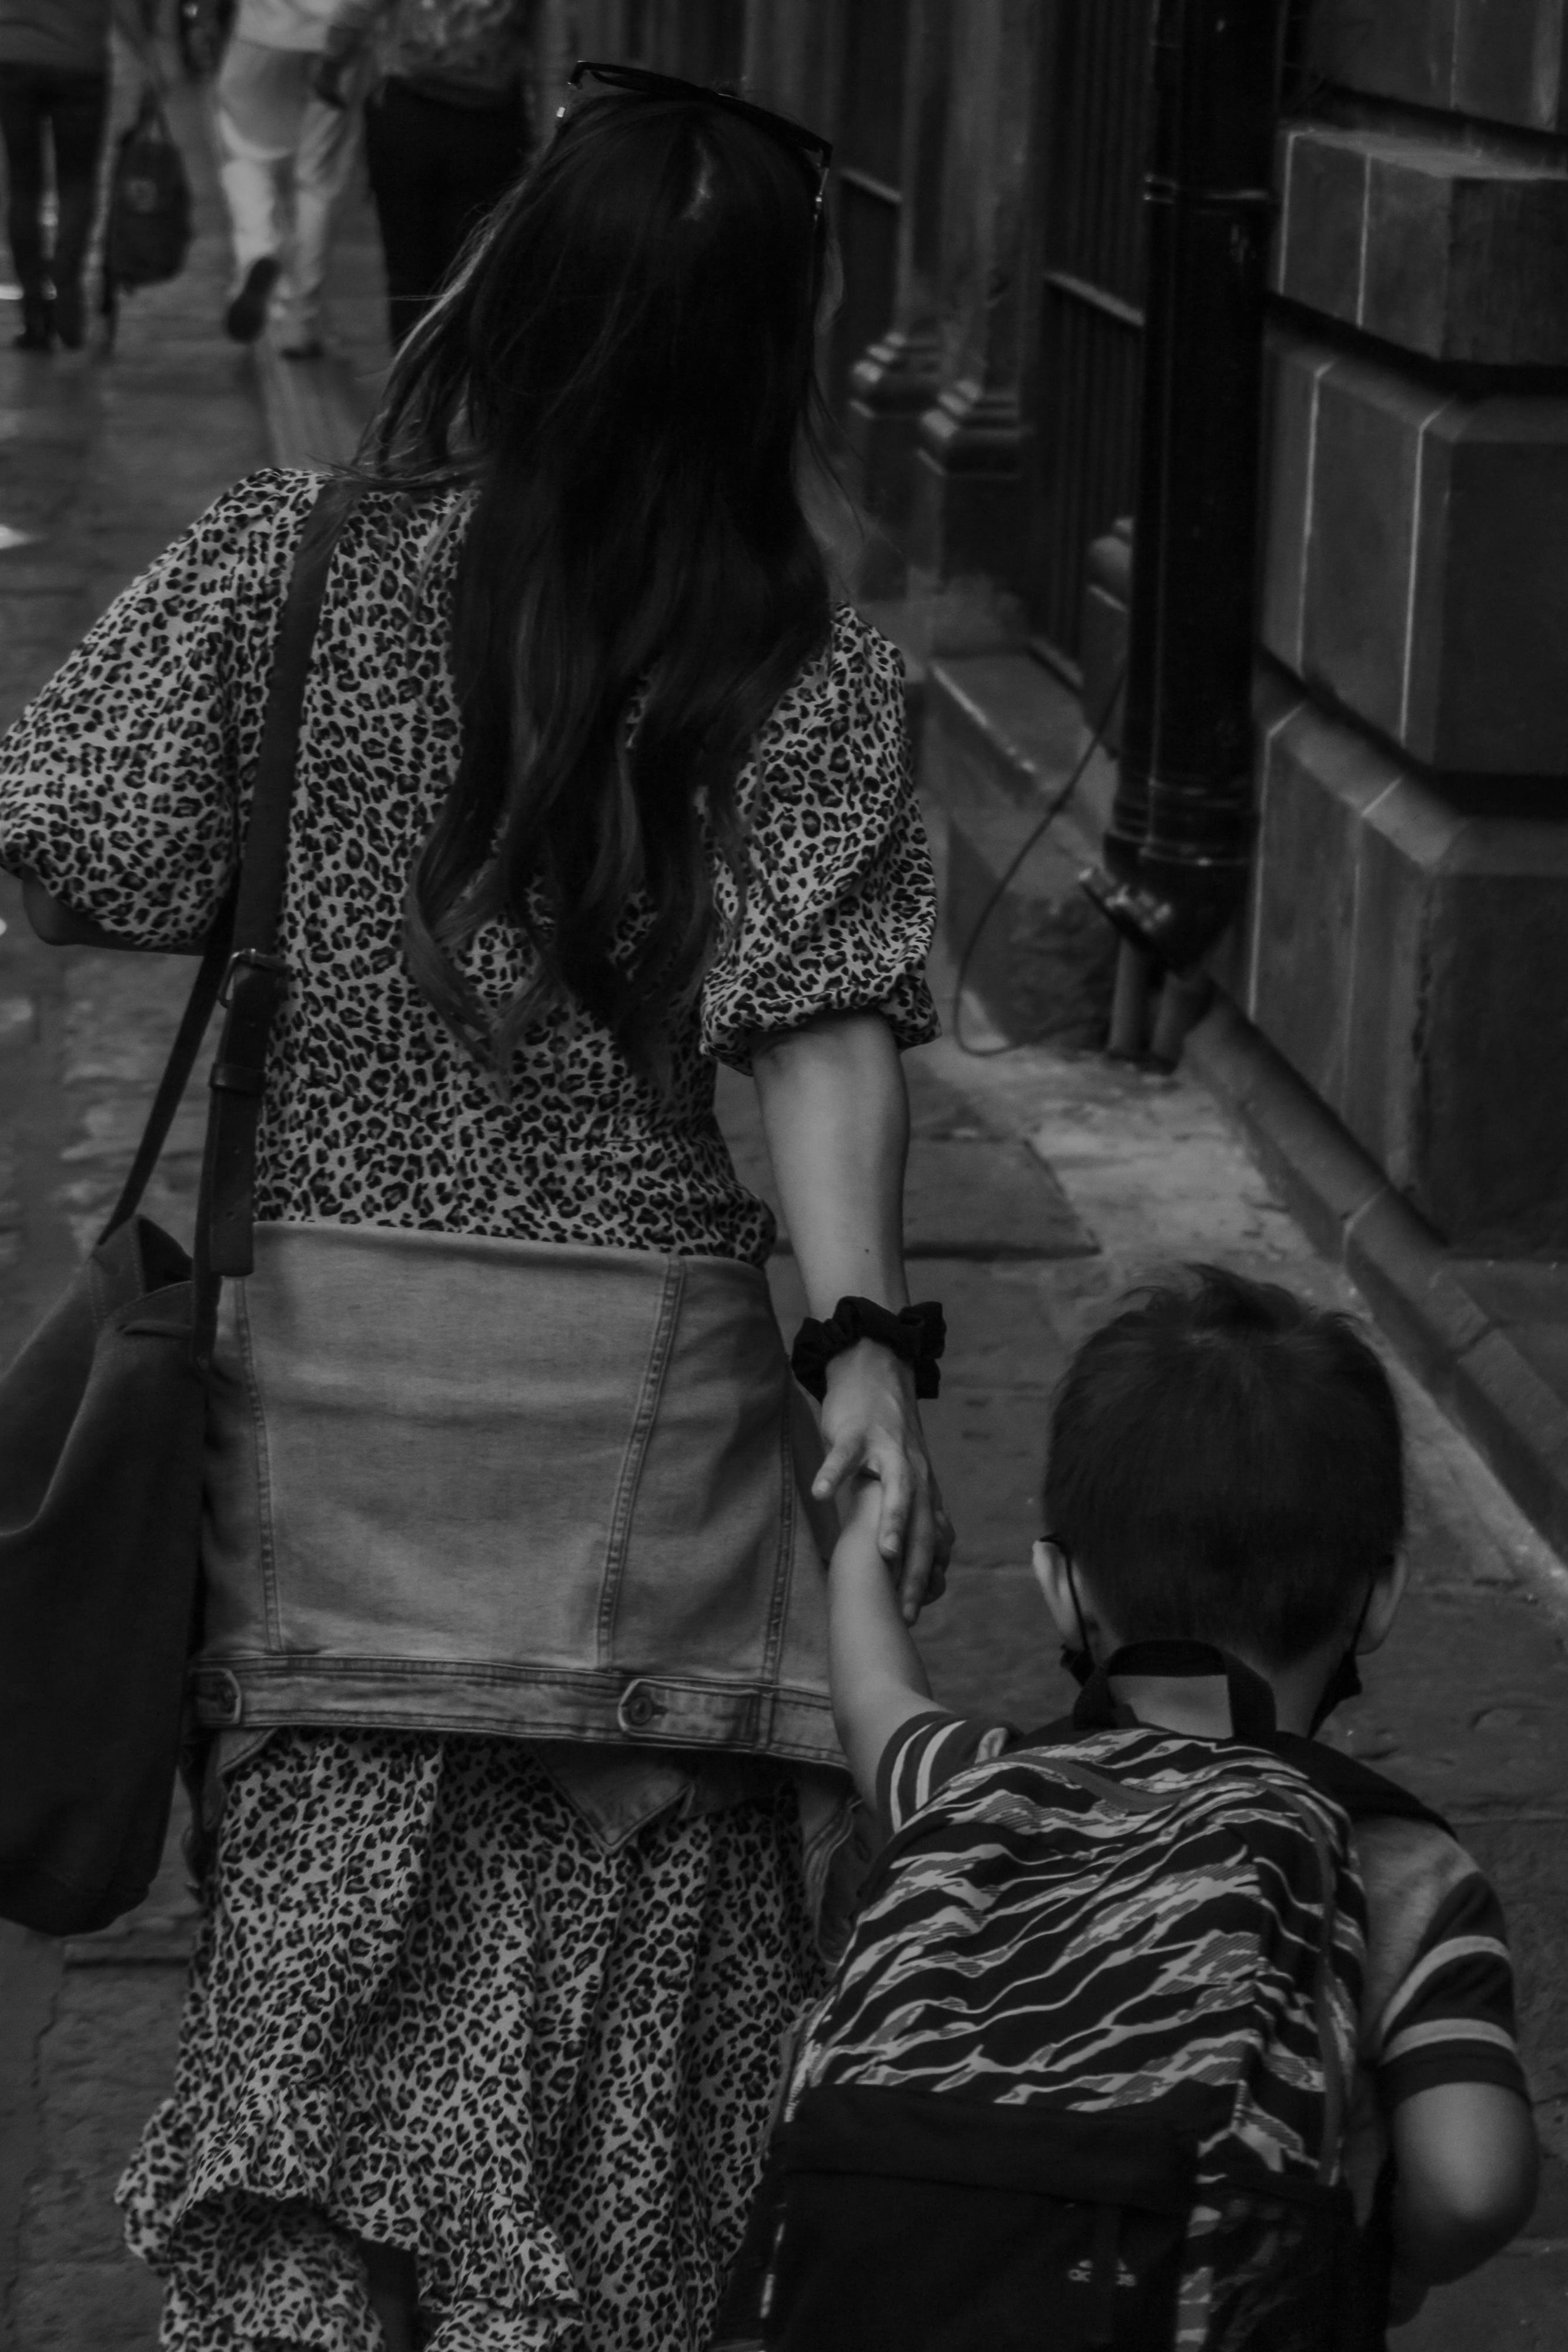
[216,0,360,360]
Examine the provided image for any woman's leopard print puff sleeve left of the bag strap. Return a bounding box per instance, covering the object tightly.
[0,473,317,948]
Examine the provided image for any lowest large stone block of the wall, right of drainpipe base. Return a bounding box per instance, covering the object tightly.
[1234,680,1568,1254]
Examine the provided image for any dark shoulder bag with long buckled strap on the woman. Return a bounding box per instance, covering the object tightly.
[0,485,357,1936]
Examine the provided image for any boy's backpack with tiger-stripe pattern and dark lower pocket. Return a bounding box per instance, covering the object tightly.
[717,1661,1434,2352]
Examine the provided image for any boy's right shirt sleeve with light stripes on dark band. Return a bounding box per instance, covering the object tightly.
[1366,1839,1530,2107]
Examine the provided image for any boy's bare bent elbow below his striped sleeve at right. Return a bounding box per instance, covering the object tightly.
[1392,2082,1540,2286]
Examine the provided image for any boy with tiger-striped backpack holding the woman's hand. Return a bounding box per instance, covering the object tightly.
[747,1268,1535,2352]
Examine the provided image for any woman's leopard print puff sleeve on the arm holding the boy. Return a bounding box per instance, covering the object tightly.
[701,604,938,1070]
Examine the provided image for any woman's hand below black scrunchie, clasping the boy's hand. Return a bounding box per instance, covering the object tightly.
[811,1338,952,1625]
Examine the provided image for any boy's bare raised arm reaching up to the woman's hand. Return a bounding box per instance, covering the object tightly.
[827,1479,931,1806]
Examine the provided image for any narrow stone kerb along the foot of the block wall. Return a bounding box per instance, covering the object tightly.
[1187,997,1568,1611]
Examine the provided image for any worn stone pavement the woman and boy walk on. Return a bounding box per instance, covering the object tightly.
[0,51,1568,2352]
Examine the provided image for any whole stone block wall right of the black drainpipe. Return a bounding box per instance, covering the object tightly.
[1232,0,1568,1254]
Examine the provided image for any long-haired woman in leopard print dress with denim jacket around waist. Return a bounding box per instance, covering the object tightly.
[0,75,950,2352]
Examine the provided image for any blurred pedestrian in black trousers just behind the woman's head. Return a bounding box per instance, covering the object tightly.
[317,0,534,350]
